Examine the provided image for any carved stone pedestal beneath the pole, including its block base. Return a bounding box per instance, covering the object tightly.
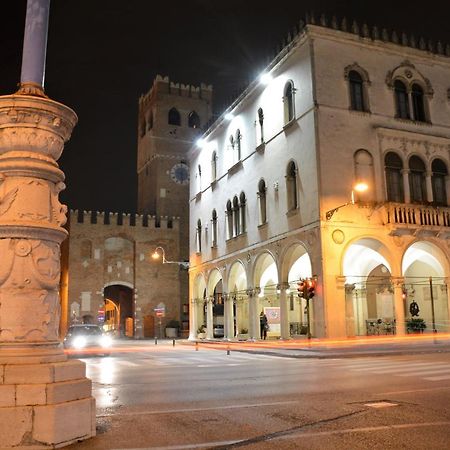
[0,90,95,449]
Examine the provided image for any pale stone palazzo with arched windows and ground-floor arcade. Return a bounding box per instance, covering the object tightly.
[190,17,450,339]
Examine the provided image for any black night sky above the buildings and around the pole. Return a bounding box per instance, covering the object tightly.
[0,0,450,211]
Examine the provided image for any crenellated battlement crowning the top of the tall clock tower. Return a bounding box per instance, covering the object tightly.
[139,75,213,107]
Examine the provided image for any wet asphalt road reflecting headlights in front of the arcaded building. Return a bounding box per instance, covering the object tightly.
[68,343,450,450]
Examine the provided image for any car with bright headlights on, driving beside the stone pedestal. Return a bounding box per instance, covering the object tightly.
[63,324,112,355]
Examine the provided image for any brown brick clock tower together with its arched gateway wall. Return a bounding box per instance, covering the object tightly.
[61,75,212,338]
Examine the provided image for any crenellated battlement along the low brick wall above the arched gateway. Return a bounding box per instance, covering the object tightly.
[69,209,180,230]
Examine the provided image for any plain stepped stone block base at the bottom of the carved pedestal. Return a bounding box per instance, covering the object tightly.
[0,355,95,450]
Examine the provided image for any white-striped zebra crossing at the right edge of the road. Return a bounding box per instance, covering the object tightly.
[330,359,450,381]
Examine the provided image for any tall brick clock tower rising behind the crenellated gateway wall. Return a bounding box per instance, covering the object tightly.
[137,75,212,260]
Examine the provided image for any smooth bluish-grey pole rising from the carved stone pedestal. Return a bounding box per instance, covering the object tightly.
[20,0,50,88]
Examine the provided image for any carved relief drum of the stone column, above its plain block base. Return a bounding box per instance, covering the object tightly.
[0,239,60,342]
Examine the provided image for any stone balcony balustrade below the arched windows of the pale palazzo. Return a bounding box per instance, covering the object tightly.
[385,203,450,229]
